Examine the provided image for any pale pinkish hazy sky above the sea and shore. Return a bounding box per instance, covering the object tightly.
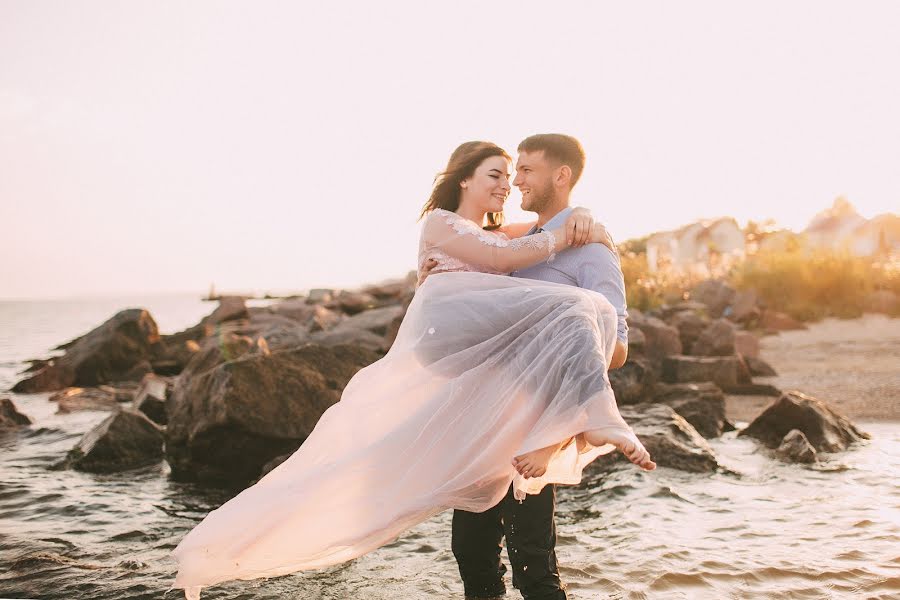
[0,0,900,298]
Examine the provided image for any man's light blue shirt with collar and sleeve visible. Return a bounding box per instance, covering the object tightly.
[510,207,628,345]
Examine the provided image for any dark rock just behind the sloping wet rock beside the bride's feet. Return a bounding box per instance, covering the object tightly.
[653,382,734,438]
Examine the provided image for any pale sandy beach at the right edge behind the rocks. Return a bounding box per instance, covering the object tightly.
[727,314,900,421]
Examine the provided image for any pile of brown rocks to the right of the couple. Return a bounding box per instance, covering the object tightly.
[609,280,868,472]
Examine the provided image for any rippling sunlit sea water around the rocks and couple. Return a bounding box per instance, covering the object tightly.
[0,296,900,600]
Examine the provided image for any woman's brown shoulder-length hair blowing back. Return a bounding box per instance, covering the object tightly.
[419,142,512,229]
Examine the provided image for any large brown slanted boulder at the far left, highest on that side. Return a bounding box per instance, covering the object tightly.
[12,308,160,394]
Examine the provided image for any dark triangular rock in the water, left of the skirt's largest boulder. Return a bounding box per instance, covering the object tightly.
[59,410,163,473]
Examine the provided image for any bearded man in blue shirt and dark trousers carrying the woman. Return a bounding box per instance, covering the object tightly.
[452,134,628,600]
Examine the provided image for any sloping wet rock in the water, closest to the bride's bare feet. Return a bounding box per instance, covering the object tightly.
[617,404,719,473]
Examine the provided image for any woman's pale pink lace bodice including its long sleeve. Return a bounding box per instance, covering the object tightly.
[418,208,556,281]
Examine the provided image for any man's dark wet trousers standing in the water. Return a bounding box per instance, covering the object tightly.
[452,485,567,600]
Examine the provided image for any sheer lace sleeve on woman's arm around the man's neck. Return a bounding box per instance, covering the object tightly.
[424,209,559,273]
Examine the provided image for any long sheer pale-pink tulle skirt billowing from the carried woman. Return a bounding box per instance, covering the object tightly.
[174,273,631,599]
